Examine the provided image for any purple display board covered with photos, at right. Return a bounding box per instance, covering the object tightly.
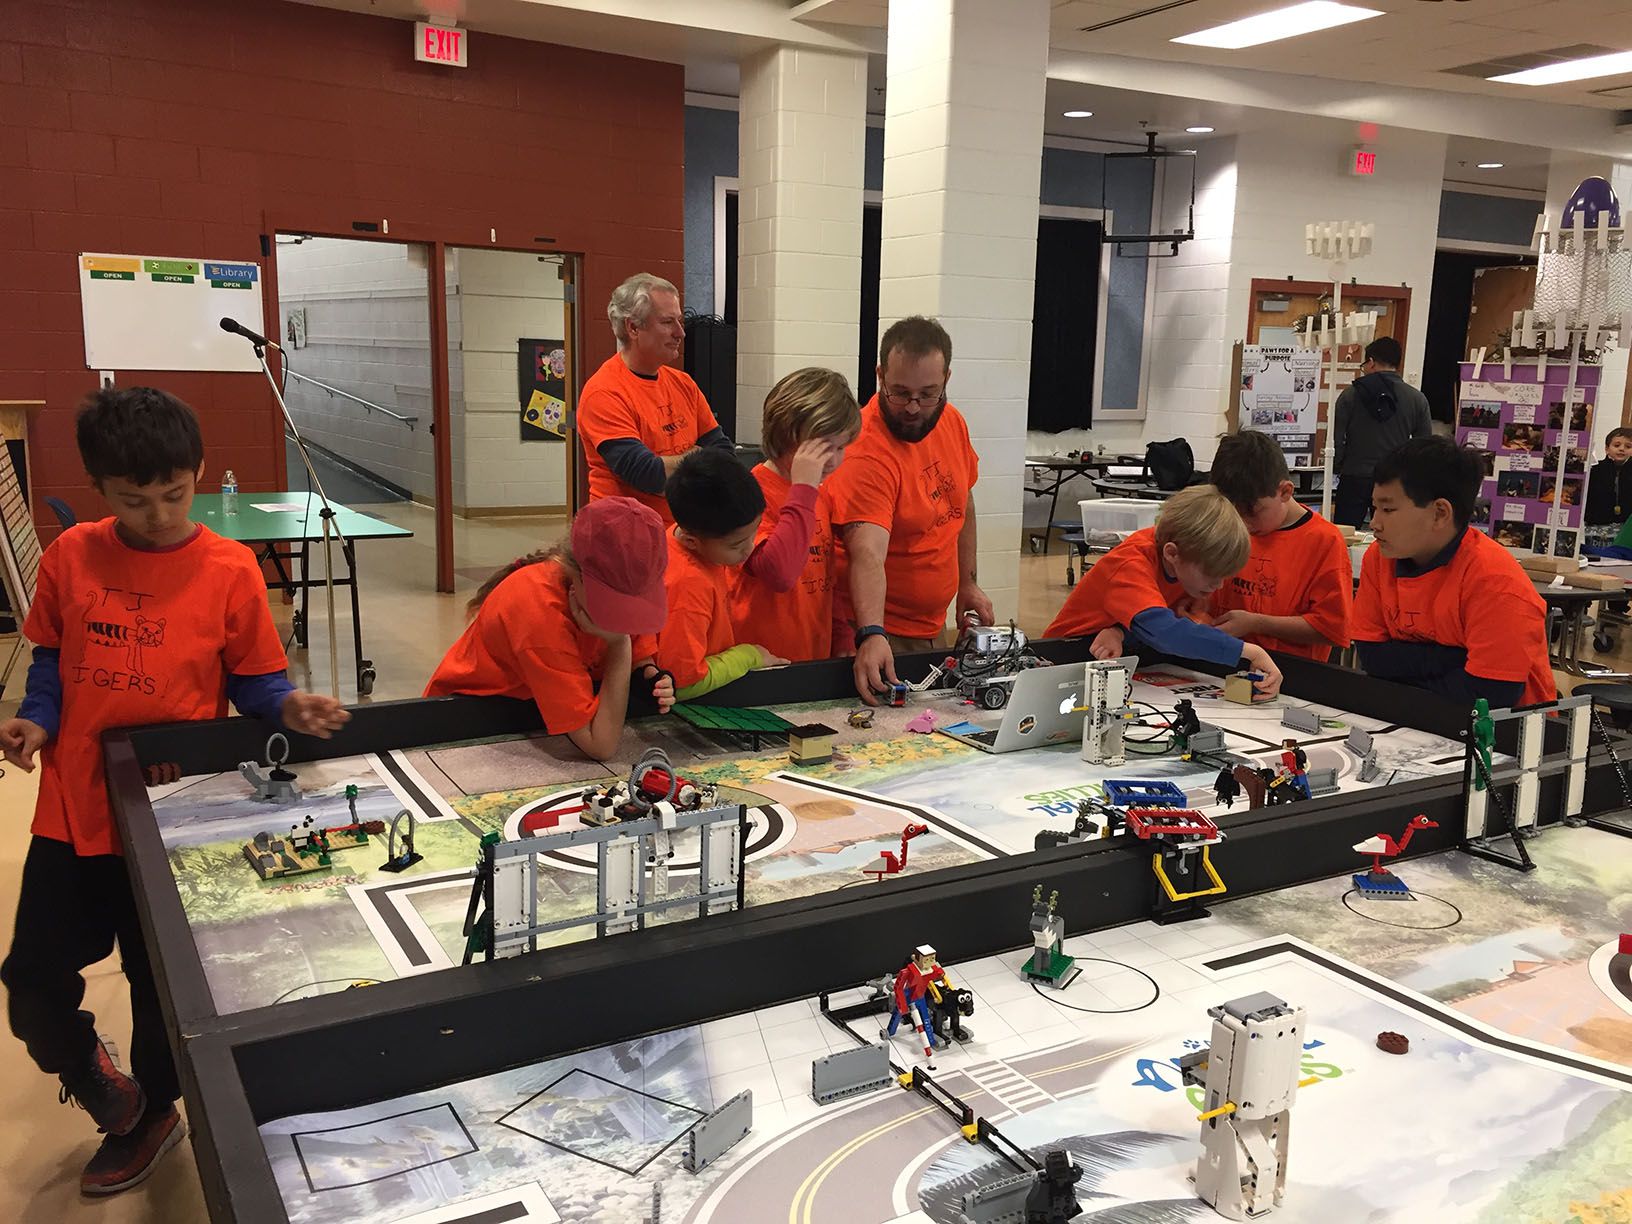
[1456,362,1599,557]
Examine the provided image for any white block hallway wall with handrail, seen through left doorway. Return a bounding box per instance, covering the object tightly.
[277,238,434,499]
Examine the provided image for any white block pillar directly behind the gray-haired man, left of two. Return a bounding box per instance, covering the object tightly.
[736,47,867,442]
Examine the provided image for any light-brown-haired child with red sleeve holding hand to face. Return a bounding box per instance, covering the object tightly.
[731,367,862,663]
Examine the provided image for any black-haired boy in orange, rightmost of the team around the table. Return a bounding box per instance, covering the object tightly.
[1355,437,1559,707]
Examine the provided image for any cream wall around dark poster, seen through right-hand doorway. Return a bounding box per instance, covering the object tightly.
[449,248,566,512]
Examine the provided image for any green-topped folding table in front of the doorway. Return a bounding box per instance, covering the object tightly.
[193,491,413,697]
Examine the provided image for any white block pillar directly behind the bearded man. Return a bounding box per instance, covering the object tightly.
[878,0,1049,617]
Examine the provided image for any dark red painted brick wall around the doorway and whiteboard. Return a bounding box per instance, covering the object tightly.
[0,0,684,535]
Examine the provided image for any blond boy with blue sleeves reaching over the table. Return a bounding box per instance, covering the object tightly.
[1044,485,1281,697]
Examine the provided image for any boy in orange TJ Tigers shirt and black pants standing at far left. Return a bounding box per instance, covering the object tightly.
[0,387,349,1195]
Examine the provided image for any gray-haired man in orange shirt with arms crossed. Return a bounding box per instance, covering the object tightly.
[578,273,731,522]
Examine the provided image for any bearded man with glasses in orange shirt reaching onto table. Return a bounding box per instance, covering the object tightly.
[829,315,992,705]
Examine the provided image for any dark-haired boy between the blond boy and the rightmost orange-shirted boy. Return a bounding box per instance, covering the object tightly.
[1208,429,1355,661]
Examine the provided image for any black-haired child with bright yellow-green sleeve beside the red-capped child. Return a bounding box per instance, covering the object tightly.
[658,450,787,702]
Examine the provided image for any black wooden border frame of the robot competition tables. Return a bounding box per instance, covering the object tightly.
[103,641,1622,1224]
